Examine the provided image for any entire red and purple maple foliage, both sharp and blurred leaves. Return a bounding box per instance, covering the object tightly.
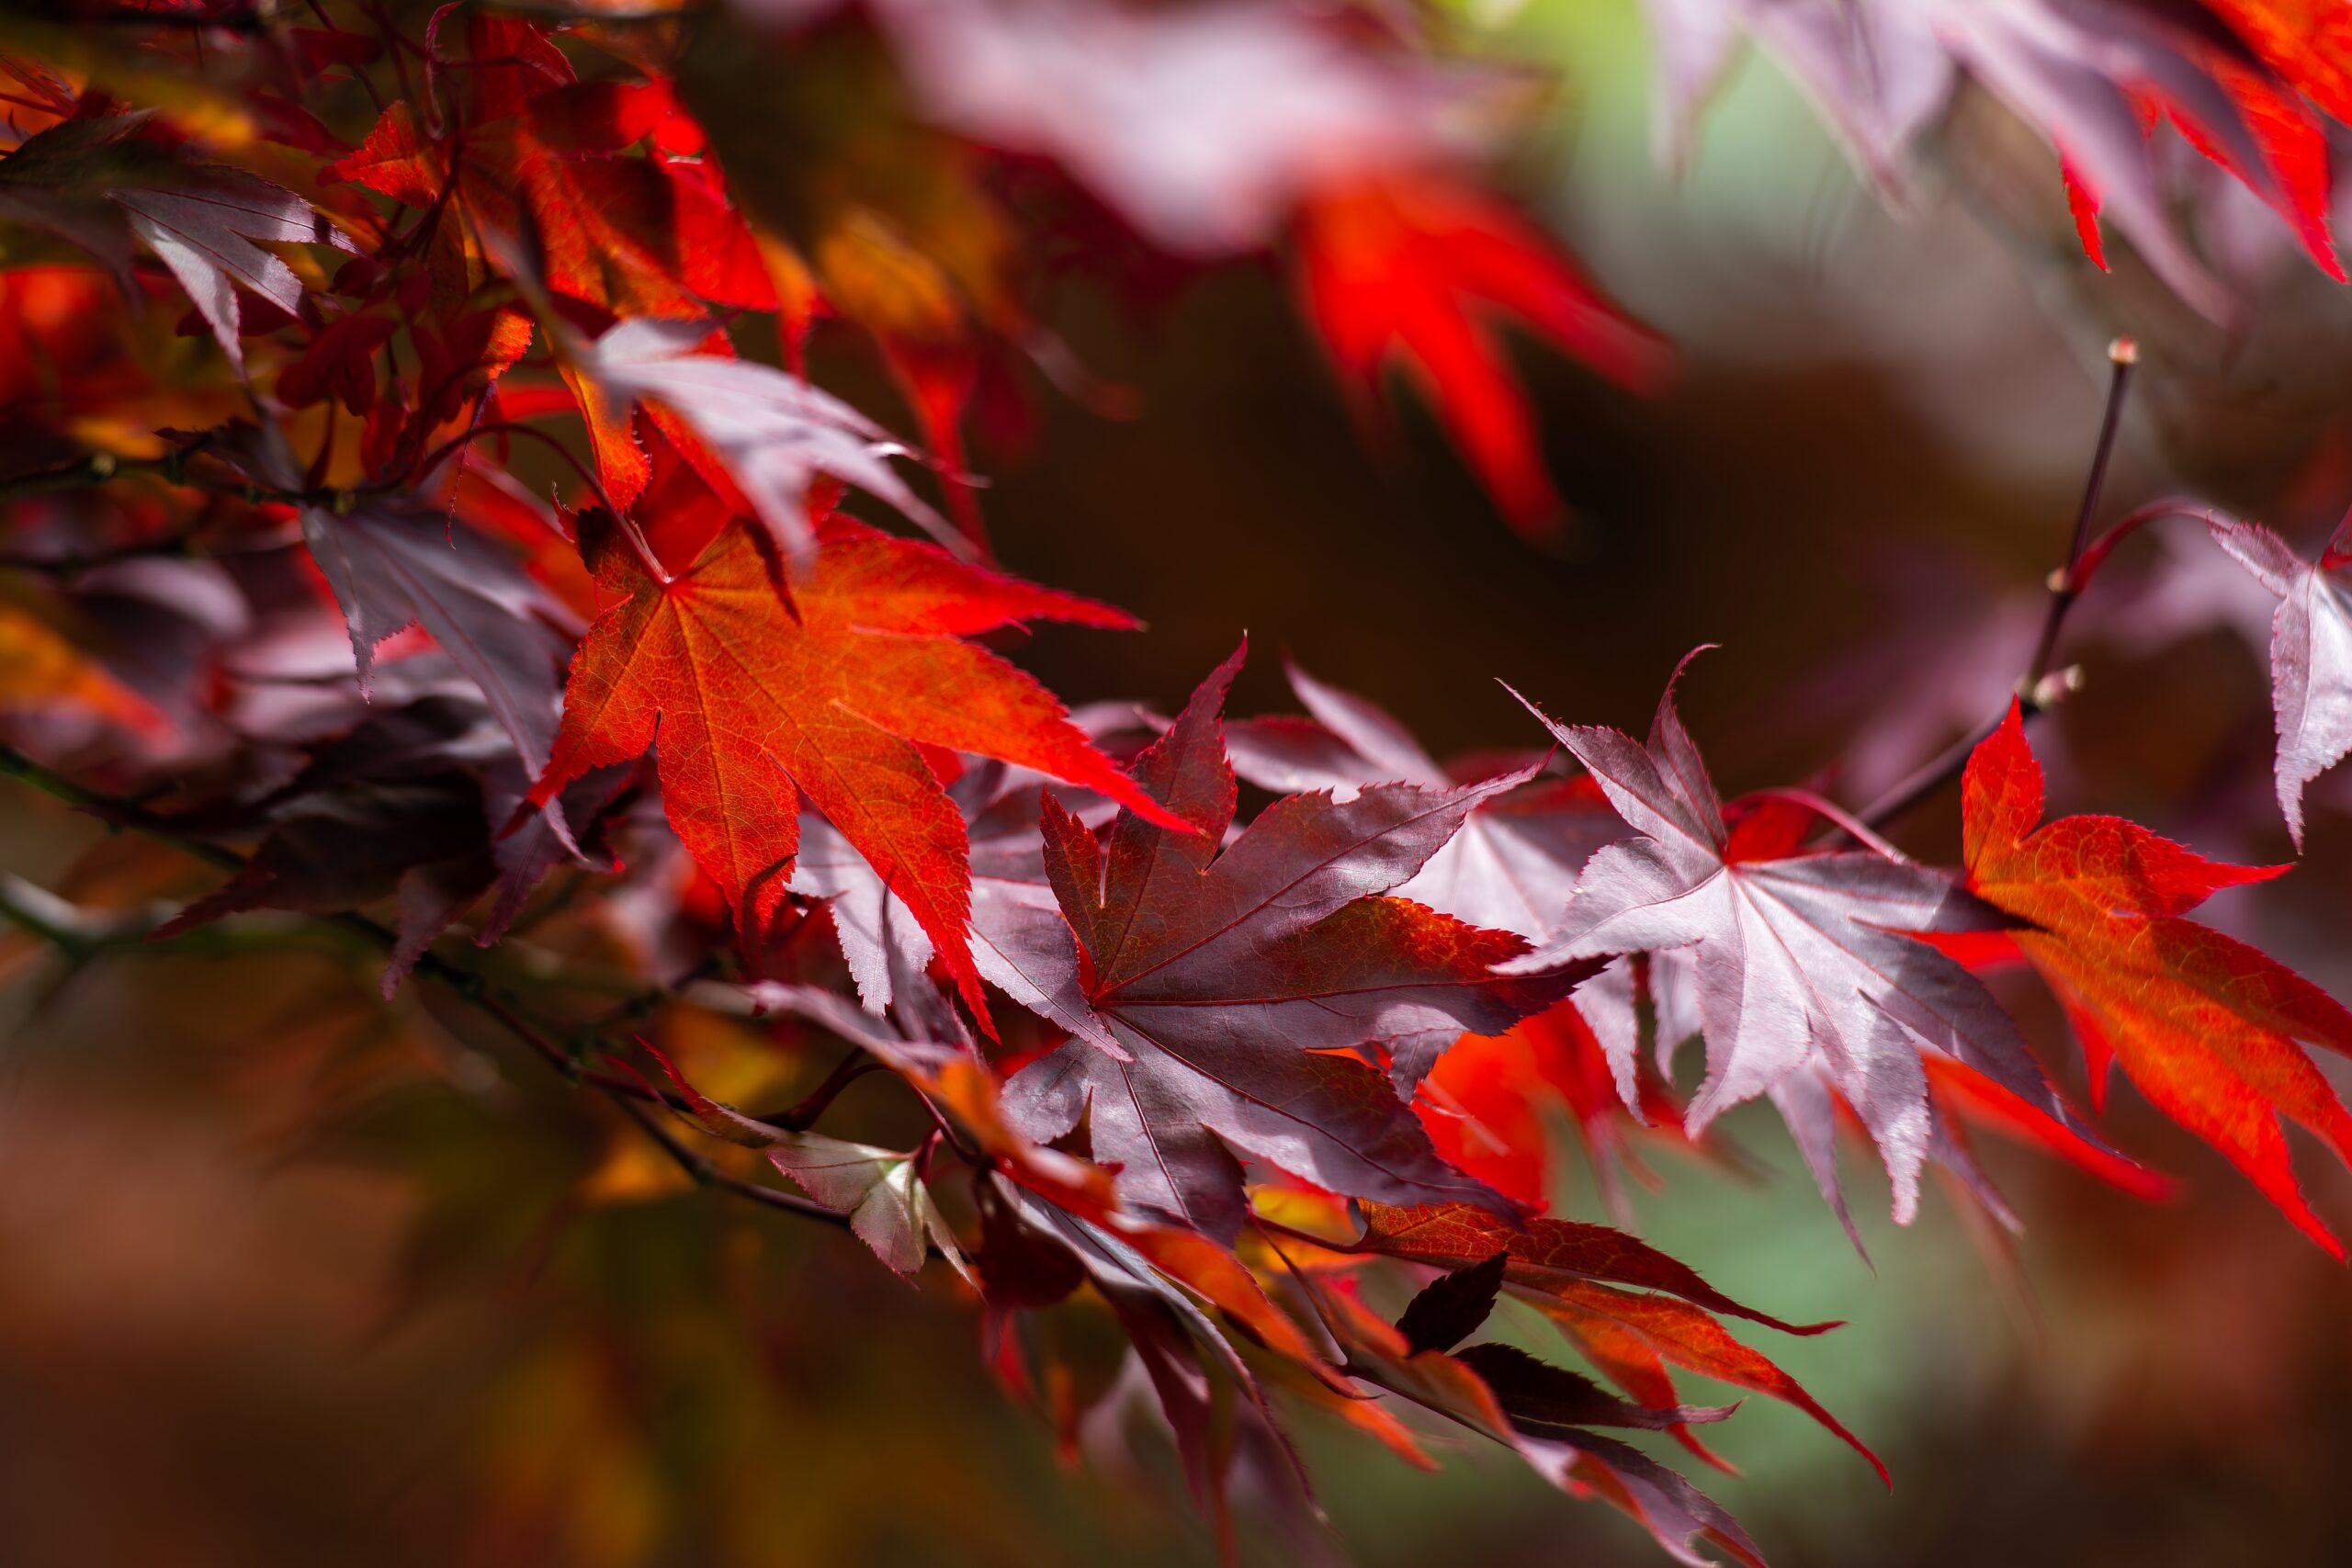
[0,0,2352,1561]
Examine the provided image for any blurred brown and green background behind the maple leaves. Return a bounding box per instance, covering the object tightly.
[0,0,2352,1568]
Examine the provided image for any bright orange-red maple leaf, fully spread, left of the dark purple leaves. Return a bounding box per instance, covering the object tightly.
[529,513,1173,1022]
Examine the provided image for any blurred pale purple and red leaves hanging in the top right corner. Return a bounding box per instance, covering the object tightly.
[1642,0,2352,320]
